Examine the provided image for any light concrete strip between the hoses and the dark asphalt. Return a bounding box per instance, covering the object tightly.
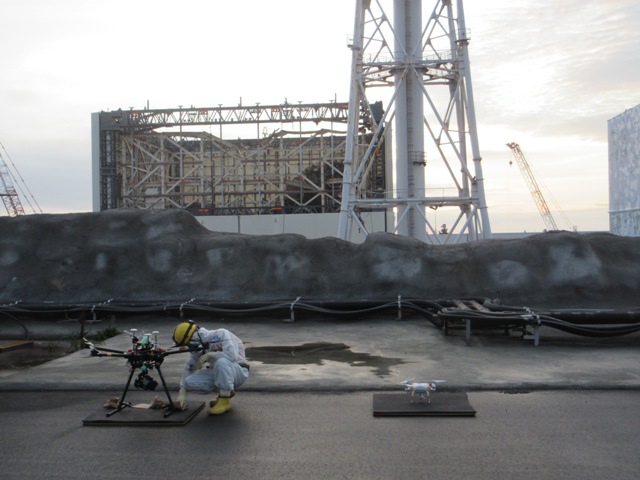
[0,317,640,393]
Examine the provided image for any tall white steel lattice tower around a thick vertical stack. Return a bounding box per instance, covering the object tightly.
[338,0,491,243]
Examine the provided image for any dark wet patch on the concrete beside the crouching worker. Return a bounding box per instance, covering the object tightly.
[246,342,405,377]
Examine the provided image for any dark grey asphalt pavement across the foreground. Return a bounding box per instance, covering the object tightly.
[0,391,640,480]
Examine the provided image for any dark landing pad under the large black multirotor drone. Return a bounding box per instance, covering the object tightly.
[82,402,204,427]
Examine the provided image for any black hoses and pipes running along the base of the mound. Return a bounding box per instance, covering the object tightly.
[0,297,640,337]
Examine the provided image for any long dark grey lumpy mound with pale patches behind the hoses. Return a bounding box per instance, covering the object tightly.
[0,210,640,308]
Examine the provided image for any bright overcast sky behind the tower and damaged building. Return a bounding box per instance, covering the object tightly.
[0,0,640,232]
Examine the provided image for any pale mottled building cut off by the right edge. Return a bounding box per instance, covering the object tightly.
[608,105,640,237]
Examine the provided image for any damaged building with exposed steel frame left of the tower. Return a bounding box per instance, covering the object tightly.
[93,102,384,215]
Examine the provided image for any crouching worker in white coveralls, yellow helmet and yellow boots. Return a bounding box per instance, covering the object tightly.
[173,321,249,415]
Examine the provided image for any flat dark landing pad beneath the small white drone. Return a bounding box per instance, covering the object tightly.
[373,392,476,417]
